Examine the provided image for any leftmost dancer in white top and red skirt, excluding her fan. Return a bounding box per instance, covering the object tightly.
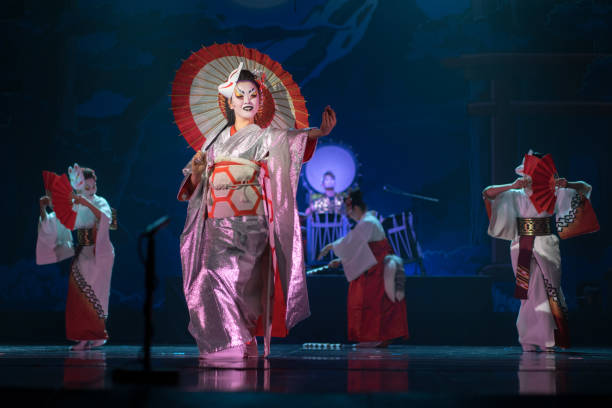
[36,164,115,350]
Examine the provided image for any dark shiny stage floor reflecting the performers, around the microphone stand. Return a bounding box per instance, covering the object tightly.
[0,345,612,396]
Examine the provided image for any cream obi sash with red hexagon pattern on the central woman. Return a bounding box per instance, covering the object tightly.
[207,158,264,218]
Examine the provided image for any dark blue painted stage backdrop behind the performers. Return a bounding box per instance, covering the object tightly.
[0,0,612,322]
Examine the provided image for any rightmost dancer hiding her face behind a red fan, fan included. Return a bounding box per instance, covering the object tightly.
[483,151,599,351]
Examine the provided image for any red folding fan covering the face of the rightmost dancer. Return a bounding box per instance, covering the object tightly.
[524,154,557,214]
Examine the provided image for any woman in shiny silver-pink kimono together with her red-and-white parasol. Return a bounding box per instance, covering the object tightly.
[172,44,336,360]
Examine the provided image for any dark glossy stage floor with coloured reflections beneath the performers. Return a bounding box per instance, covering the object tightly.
[0,344,612,408]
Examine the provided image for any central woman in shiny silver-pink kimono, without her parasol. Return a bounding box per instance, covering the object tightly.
[179,63,336,359]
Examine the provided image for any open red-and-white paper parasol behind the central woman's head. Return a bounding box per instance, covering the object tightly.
[171,43,308,151]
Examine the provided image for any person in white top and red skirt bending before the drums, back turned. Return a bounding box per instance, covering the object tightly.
[319,190,408,347]
